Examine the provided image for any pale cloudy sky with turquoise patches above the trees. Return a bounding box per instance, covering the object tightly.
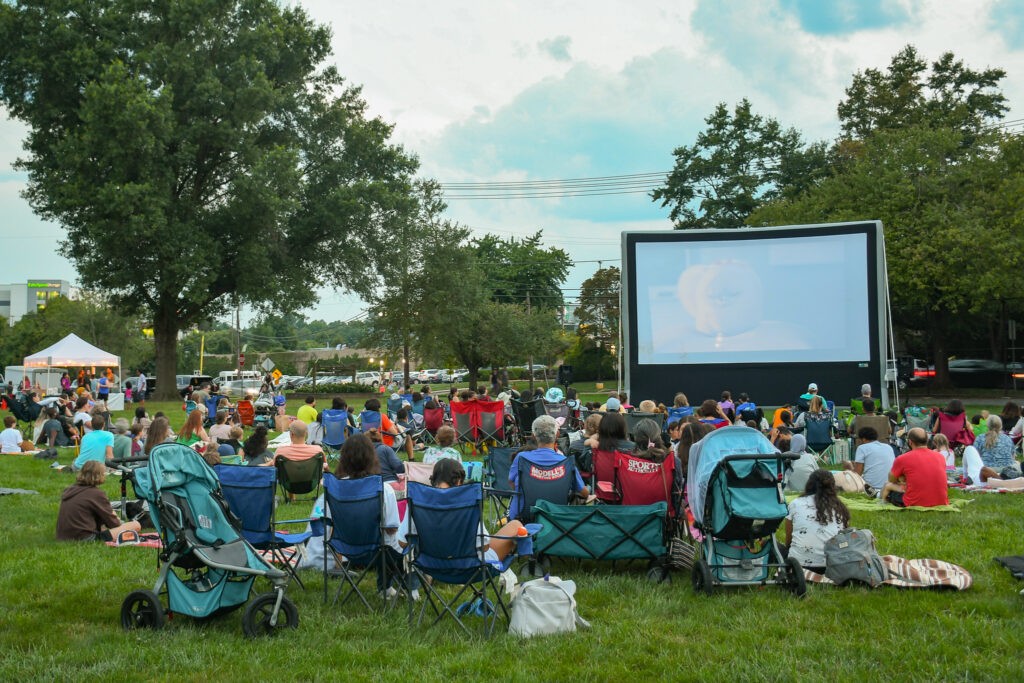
[0,0,1024,321]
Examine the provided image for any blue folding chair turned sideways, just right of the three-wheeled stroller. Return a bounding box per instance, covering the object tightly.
[213,465,312,589]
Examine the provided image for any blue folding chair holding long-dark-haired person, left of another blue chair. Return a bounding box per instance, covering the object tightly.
[324,473,403,610]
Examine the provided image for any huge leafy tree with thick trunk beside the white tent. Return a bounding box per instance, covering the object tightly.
[0,0,416,393]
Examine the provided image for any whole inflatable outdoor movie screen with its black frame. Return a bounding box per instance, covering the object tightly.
[623,221,886,404]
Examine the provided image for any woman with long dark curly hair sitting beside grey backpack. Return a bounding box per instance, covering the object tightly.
[785,470,850,573]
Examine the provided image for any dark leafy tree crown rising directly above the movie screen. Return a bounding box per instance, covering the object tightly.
[651,98,827,229]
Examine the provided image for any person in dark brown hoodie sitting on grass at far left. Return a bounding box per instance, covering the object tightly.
[56,460,142,541]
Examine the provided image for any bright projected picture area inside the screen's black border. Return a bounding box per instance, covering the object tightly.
[636,234,869,365]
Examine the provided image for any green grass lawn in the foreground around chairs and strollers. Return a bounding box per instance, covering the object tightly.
[0,403,1024,681]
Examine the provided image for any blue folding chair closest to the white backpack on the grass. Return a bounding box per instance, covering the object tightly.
[407,481,539,636]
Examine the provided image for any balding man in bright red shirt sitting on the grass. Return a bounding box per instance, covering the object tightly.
[882,427,949,508]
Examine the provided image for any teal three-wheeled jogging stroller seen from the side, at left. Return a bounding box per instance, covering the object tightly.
[121,443,299,637]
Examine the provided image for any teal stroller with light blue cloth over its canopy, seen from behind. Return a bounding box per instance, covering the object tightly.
[687,427,807,596]
